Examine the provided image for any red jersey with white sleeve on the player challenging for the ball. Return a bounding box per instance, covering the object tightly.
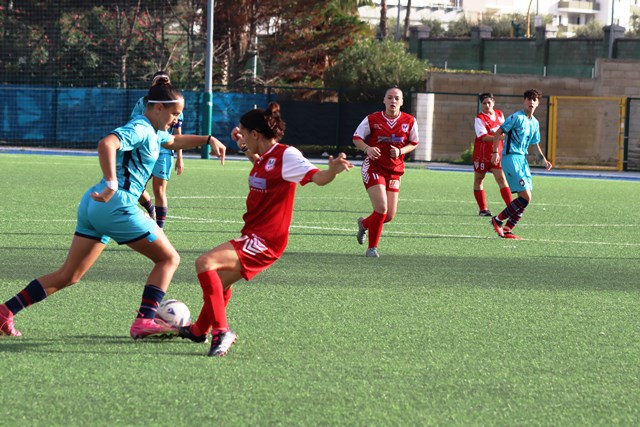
[242,144,319,256]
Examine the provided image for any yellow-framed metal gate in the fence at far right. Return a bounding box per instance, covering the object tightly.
[547,96,626,171]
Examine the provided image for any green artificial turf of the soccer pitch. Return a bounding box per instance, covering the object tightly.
[0,154,640,426]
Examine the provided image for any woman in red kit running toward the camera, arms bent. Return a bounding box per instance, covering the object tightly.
[353,87,418,258]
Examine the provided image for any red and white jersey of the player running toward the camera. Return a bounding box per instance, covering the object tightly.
[353,111,418,174]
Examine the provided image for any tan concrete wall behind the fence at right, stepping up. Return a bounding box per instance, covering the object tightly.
[414,59,640,170]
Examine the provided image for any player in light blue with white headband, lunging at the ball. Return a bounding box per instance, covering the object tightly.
[0,84,226,339]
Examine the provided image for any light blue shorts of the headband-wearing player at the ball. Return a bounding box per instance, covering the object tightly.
[75,184,158,245]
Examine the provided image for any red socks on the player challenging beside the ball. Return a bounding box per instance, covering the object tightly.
[191,270,229,335]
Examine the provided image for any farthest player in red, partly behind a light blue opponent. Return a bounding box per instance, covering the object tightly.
[473,93,511,216]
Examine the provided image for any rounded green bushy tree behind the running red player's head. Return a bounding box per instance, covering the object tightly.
[324,39,429,101]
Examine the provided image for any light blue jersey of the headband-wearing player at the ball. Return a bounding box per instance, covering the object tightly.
[111,116,170,200]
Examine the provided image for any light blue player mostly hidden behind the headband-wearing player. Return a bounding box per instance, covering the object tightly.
[131,71,184,228]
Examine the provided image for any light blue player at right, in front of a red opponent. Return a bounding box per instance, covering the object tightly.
[491,89,553,240]
